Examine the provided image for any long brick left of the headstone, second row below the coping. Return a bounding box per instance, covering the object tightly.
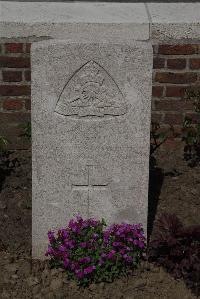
[0,56,30,68]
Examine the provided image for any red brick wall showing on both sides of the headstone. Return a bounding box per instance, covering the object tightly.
[0,43,200,149]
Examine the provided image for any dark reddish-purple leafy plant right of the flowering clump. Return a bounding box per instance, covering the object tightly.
[148,214,200,295]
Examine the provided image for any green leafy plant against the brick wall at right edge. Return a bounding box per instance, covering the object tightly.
[182,86,200,167]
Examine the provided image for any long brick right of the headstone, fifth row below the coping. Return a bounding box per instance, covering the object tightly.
[154,99,194,111]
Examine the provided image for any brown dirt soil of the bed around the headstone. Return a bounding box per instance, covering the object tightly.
[0,143,200,299]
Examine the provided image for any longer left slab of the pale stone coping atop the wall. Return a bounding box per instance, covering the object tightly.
[0,1,149,42]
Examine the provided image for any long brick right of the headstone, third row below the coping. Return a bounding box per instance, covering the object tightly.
[155,72,197,84]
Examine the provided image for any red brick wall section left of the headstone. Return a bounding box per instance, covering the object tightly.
[0,43,31,149]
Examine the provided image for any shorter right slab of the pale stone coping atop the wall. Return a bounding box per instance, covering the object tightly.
[147,2,200,42]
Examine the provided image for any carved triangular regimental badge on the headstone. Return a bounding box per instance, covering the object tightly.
[55,61,127,117]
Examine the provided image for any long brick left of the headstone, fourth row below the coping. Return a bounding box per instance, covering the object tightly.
[0,85,31,96]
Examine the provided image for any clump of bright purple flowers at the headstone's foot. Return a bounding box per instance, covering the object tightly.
[46,216,145,286]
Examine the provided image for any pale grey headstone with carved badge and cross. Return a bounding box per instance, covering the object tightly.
[31,40,152,258]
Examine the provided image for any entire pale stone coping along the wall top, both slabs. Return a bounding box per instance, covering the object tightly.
[0,1,200,43]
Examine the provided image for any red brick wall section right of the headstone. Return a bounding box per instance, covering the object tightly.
[152,44,200,132]
